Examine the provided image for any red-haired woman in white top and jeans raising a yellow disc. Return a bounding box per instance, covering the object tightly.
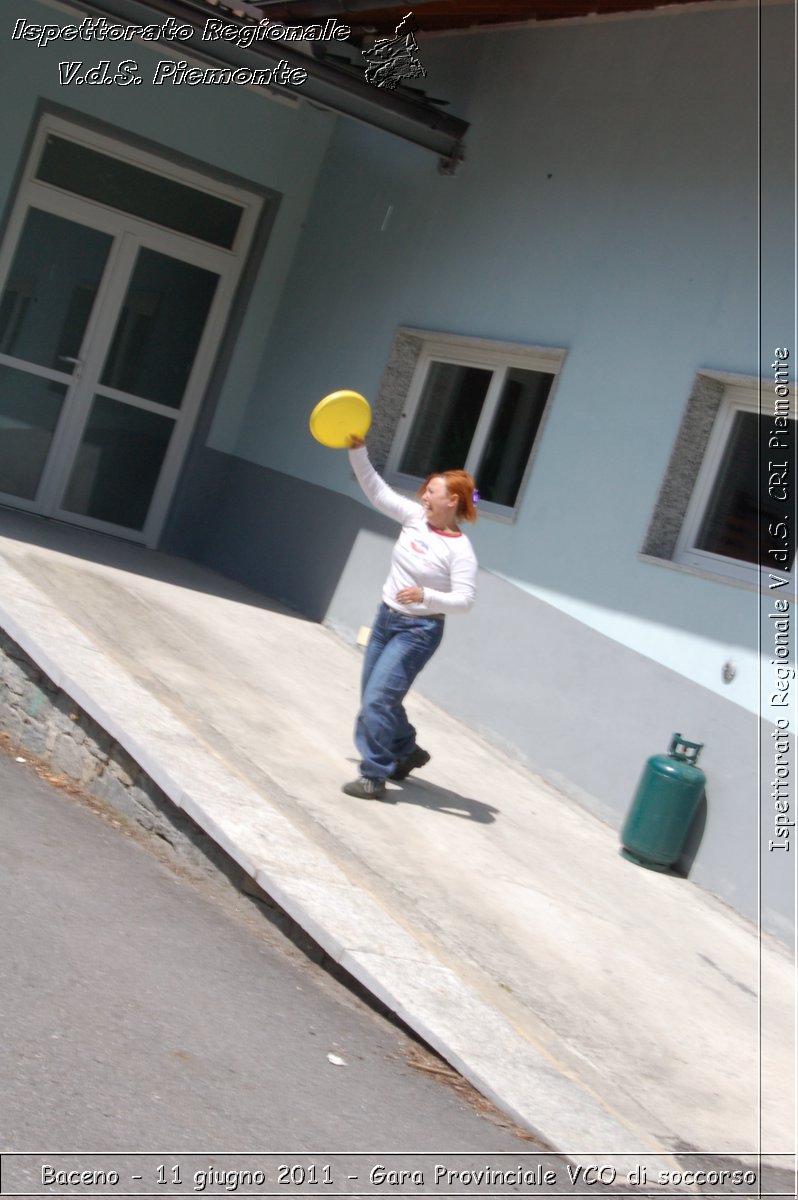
[342,437,476,799]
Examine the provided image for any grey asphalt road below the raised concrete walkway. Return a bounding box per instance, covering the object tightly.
[0,752,566,1196]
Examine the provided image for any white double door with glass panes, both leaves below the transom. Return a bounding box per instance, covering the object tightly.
[0,119,258,544]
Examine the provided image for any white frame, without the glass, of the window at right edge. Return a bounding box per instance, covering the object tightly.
[673,372,798,595]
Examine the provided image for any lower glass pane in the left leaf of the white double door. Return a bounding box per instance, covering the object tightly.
[0,367,66,500]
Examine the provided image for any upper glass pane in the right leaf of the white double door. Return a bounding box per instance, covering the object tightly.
[101,250,218,408]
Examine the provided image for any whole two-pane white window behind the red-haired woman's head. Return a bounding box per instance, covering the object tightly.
[378,331,563,516]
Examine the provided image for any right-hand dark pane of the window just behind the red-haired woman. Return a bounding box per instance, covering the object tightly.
[476,367,554,508]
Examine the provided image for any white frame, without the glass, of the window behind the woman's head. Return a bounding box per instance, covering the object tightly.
[384,330,565,522]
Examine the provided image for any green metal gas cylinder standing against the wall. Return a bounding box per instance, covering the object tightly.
[620,733,706,871]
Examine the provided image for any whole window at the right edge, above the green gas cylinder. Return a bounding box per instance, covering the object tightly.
[644,374,796,586]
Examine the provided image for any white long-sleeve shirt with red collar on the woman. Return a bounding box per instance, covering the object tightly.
[349,446,476,617]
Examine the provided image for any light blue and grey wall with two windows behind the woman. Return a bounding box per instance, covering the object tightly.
[187,7,792,931]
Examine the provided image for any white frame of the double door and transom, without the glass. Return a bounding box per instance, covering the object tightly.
[0,113,265,547]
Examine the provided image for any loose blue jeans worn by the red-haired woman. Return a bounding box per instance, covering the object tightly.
[355,604,444,779]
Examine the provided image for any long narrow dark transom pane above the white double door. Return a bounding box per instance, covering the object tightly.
[36,136,244,250]
